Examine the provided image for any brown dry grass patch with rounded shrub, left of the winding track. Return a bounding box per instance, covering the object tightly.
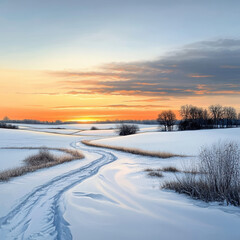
[0,147,84,181]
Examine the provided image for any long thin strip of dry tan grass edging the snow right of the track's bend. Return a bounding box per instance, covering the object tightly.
[82,140,181,158]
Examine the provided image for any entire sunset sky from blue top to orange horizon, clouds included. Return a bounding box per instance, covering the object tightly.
[0,0,240,121]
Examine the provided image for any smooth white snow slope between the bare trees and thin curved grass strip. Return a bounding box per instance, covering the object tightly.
[92,128,240,155]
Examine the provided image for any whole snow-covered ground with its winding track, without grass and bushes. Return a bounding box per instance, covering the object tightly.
[0,125,240,240]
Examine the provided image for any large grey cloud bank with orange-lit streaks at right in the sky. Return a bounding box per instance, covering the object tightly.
[51,39,240,97]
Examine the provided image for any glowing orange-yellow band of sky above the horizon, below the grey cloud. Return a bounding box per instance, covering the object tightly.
[0,69,240,123]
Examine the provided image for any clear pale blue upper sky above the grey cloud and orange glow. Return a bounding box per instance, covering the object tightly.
[0,0,240,70]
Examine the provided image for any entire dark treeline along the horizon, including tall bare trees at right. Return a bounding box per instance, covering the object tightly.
[0,104,240,131]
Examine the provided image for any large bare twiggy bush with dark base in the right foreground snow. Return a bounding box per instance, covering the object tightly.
[162,142,240,206]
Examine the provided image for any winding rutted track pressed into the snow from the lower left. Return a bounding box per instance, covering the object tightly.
[0,144,117,240]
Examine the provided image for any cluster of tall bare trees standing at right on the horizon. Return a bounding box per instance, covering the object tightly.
[157,104,240,131]
